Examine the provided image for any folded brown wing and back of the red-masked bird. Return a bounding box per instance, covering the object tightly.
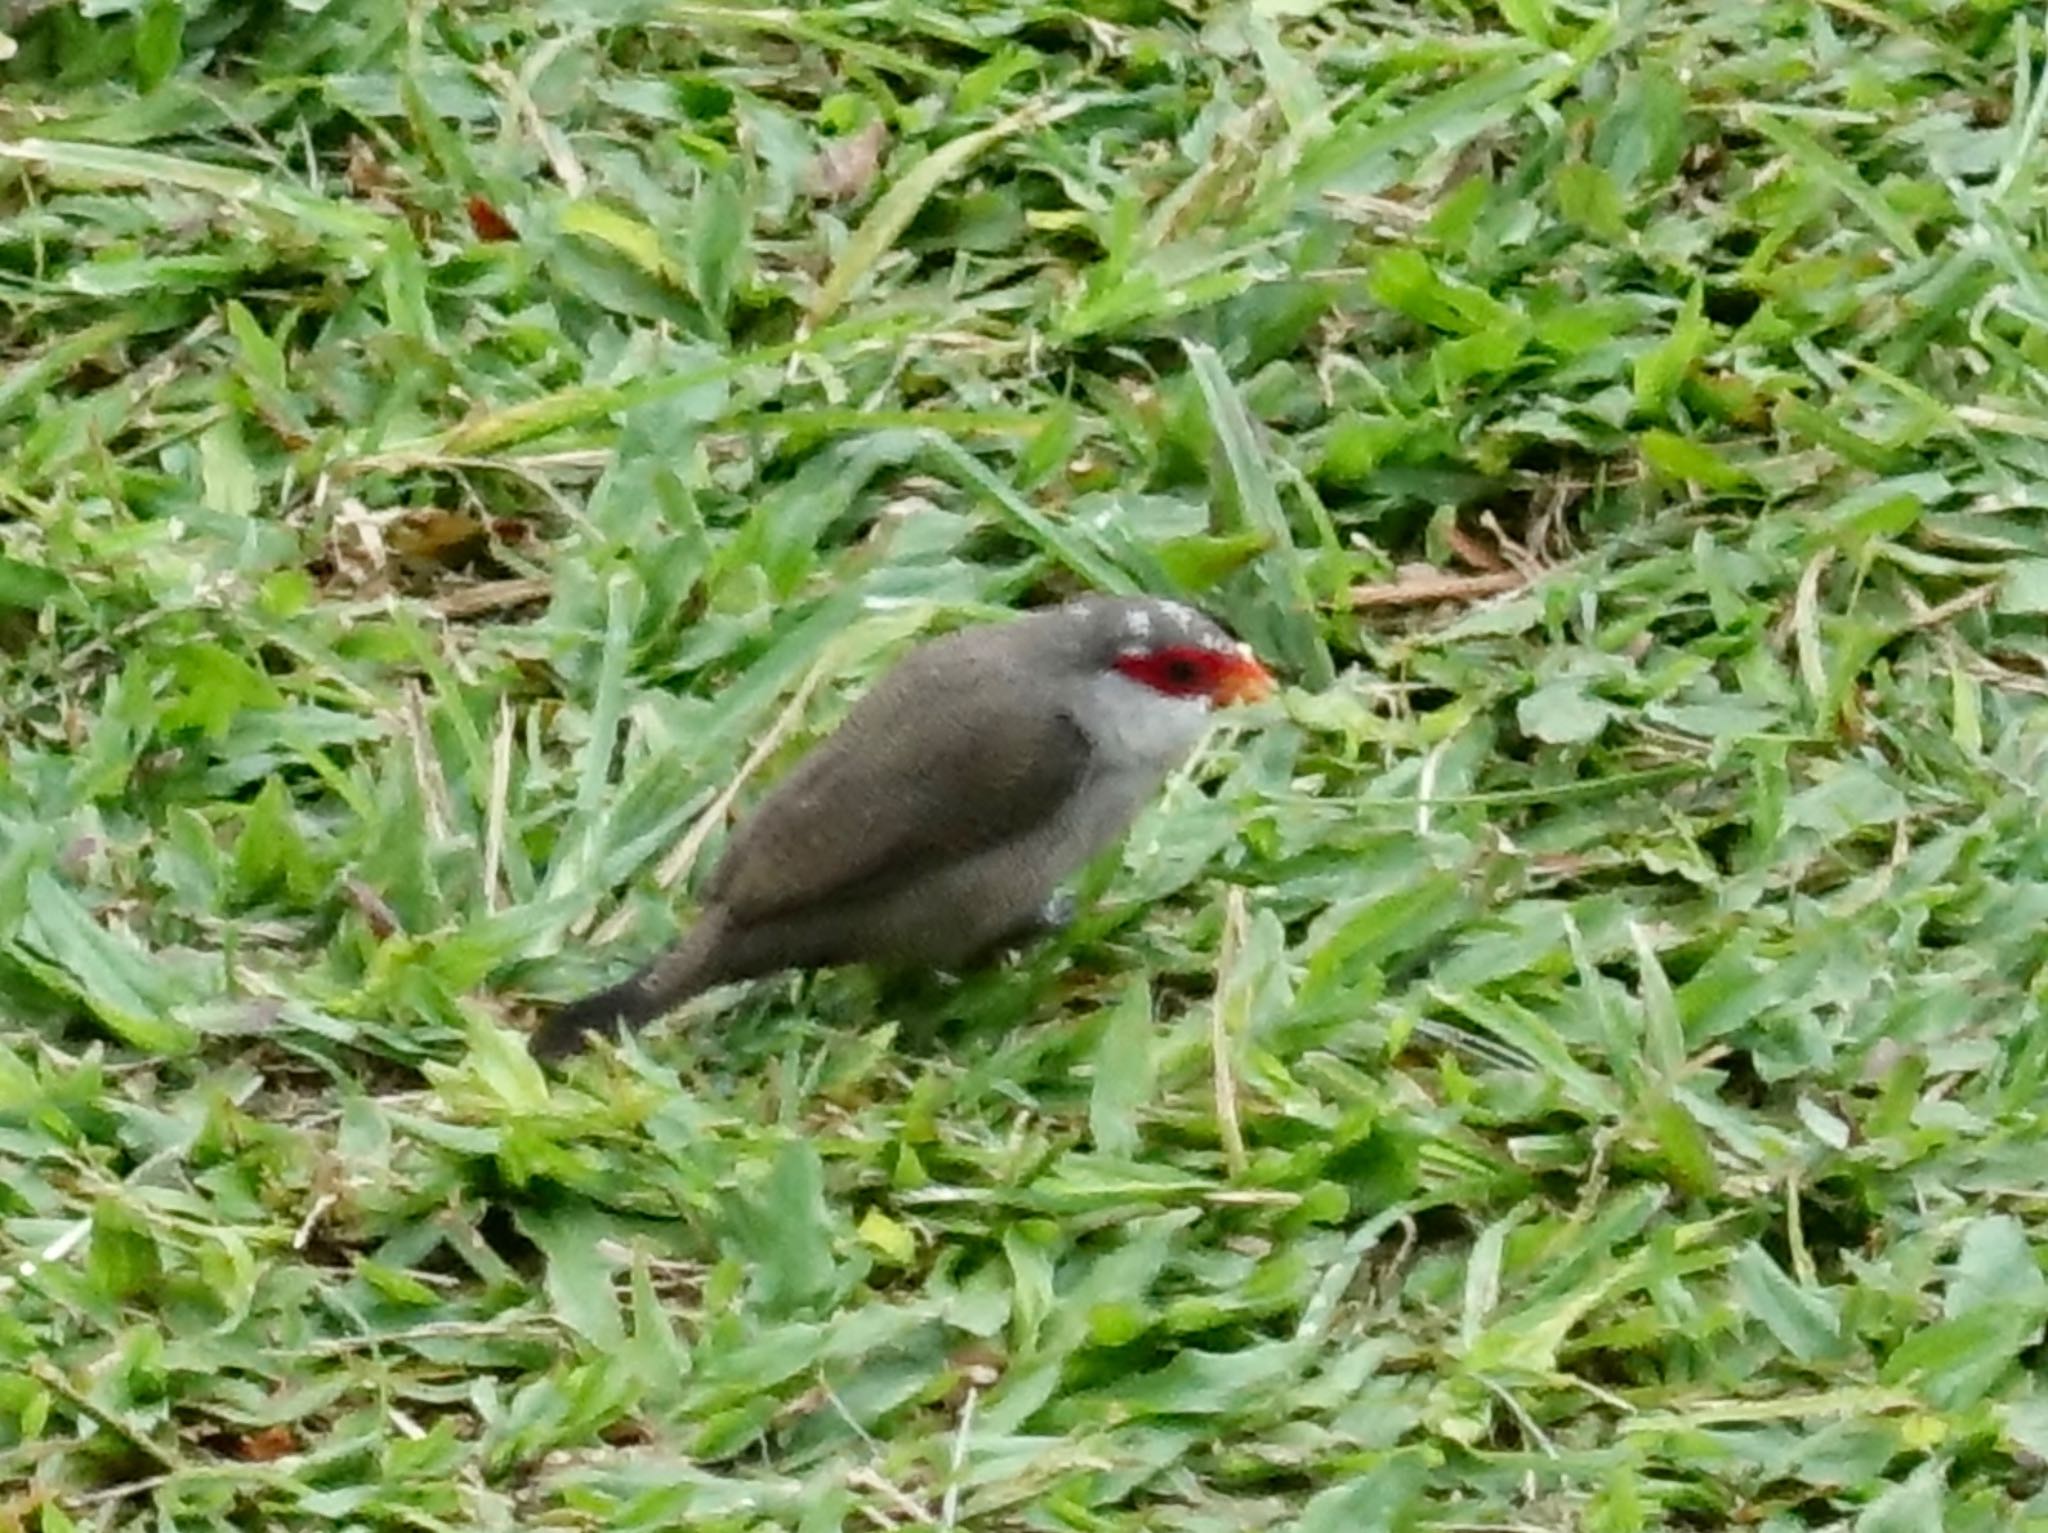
[705,634,1090,925]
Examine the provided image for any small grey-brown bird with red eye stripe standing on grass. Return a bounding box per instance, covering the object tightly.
[530,596,1274,1060]
